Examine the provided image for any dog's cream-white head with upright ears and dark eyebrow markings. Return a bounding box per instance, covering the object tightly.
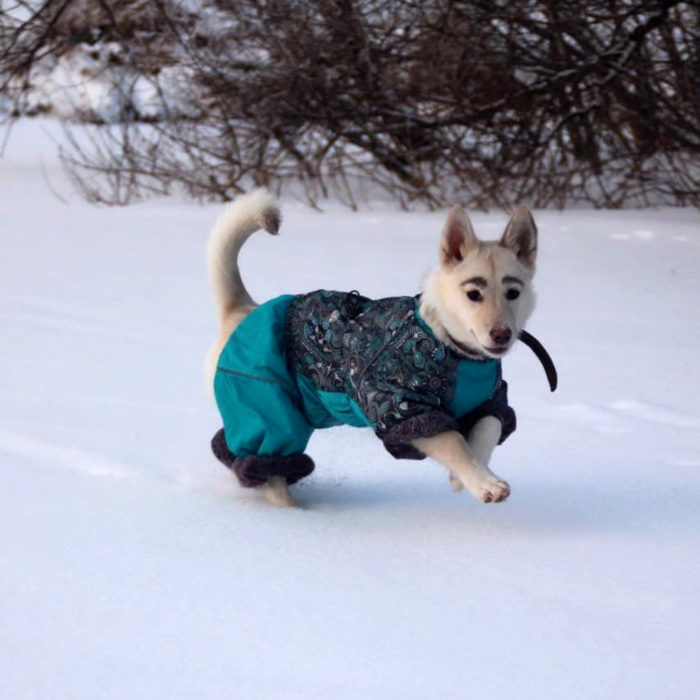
[426,207,537,358]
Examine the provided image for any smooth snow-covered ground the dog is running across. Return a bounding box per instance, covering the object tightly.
[0,124,700,700]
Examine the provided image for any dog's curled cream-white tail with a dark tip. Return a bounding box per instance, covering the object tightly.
[207,188,281,325]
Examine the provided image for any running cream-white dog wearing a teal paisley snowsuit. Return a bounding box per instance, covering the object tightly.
[206,189,537,506]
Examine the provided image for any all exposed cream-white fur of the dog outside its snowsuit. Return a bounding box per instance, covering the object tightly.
[207,194,537,506]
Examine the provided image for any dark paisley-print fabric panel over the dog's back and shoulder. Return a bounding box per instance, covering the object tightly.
[286,290,488,439]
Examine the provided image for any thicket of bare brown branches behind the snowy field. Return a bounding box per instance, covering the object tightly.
[0,0,700,208]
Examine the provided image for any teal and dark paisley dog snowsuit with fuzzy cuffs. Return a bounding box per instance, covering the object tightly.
[212,290,515,486]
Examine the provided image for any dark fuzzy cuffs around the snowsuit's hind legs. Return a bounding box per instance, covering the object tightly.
[211,428,314,488]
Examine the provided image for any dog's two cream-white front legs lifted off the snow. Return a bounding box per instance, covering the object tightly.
[413,416,510,503]
